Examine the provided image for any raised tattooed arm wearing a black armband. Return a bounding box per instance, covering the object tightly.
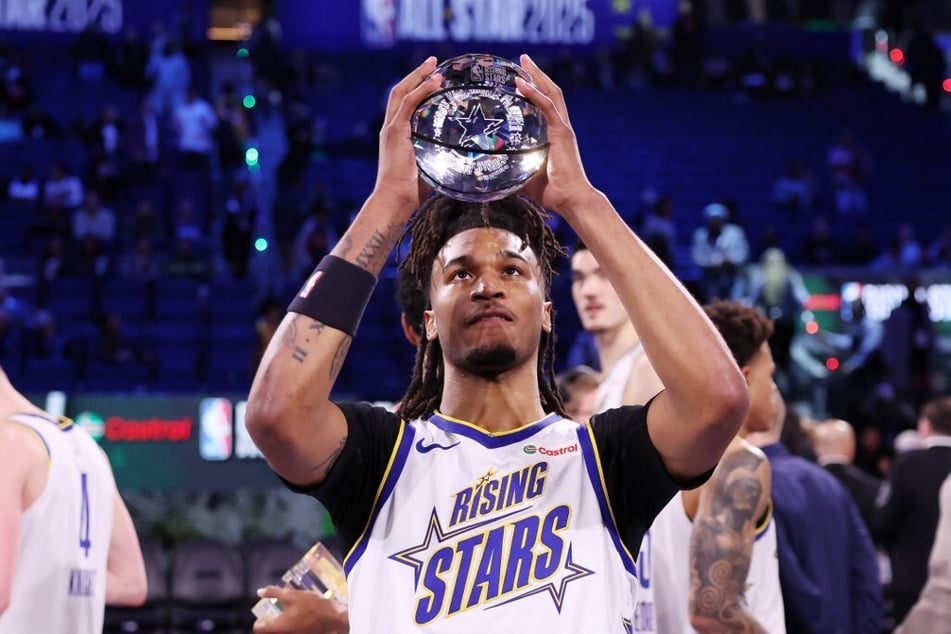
[246,58,439,484]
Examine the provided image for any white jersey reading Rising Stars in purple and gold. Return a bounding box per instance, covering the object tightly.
[344,414,636,634]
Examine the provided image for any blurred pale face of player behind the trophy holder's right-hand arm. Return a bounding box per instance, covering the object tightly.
[571,249,629,334]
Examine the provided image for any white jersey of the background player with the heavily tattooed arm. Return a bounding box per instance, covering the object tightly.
[651,493,786,634]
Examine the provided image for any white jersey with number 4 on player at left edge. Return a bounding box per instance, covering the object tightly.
[0,414,115,634]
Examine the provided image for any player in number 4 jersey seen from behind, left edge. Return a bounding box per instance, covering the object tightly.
[0,360,146,634]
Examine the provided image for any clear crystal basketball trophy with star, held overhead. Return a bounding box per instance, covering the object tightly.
[412,54,548,202]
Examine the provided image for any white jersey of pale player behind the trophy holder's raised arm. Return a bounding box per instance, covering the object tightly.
[598,343,658,632]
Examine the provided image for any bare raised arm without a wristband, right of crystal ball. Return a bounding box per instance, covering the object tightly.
[518,56,749,478]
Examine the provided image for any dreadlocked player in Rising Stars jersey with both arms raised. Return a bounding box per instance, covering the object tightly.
[247,51,749,634]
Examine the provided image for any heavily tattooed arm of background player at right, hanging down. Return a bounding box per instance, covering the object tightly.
[689,439,770,633]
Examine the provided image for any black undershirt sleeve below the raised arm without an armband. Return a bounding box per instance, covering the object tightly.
[591,405,712,553]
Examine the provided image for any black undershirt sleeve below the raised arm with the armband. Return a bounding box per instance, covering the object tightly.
[285,403,403,554]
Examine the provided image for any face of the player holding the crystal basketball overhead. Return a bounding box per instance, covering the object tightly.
[425,228,551,375]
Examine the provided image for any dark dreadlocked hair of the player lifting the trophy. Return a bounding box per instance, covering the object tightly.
[399,195,566,420]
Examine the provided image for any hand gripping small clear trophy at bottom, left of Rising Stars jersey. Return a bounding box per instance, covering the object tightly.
[253,586,350,634]
